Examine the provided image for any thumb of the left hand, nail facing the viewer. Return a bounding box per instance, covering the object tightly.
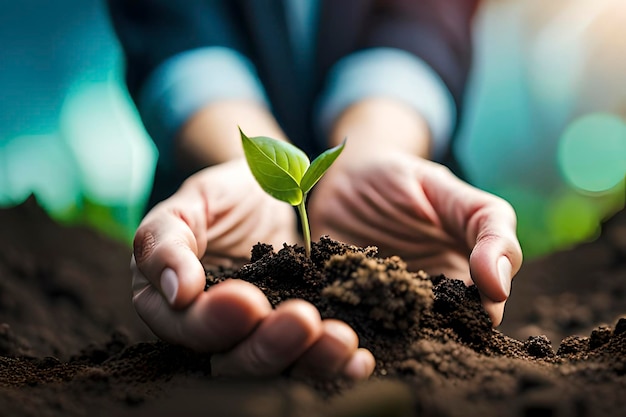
[133,197,206,308]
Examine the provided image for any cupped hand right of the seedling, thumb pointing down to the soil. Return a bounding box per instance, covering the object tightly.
[309,152,522,326]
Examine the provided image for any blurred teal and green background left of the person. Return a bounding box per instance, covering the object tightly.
[0,0,156,242]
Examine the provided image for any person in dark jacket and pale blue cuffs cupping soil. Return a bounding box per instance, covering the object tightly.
[109,0,522,379]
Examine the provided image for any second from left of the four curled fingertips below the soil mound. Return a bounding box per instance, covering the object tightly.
[211,300,322,376]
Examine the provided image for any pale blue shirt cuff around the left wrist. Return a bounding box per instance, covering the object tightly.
[137,46,269,167]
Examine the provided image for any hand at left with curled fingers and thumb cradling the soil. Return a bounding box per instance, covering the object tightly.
[131,159,375,379]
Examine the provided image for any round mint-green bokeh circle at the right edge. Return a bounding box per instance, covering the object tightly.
[557,113,626,192]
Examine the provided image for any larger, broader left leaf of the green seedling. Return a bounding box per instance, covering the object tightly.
[239,129,310,206]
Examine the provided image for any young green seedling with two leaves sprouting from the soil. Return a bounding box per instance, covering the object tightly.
[239,129,346,257]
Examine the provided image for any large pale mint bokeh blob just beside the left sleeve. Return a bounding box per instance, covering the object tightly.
[60,80,156,205]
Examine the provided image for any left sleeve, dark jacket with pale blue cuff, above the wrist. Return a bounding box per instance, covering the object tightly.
[109,0,268,170]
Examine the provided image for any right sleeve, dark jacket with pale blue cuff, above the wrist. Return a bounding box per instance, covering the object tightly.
[316,0,478,161]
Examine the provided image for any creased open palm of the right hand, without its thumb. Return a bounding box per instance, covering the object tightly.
[310,159,471,281]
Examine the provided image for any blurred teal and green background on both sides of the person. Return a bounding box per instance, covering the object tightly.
[0,0,626,259]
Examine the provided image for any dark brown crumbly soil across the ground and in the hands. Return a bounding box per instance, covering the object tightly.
[0,200,626,417]
